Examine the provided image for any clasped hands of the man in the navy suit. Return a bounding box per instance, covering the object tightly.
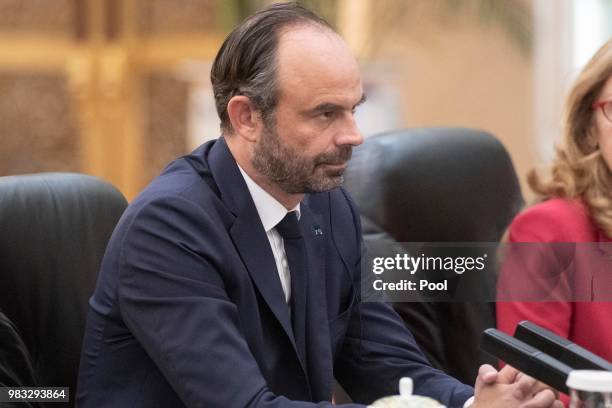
[472,364,563,408]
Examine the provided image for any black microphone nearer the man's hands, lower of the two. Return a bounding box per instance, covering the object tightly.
[480,329,572,394]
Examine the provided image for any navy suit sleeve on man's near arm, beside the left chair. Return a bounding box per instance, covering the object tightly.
[118,196,368,408]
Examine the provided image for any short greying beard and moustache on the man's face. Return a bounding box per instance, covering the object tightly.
[251,121,353,194]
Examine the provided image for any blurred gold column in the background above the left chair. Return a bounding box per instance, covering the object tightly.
[68,0,142,199]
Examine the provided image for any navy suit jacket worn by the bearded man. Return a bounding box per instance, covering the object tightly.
[77,138,473,408]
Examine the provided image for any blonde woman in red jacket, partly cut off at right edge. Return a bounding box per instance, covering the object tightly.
[497,40,612,404]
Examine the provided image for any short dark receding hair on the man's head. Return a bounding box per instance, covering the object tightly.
[210,3,332,132]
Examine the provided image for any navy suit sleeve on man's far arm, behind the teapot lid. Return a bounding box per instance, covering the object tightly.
[335,191,474,407]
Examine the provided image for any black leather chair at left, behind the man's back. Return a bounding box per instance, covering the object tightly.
[0,173,127,406]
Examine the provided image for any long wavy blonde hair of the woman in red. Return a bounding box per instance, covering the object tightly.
[527,40,612,237]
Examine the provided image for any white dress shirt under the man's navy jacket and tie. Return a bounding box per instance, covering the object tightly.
[238,166,300,304]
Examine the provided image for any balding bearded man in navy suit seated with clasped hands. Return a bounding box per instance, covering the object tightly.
[77,4,554,408]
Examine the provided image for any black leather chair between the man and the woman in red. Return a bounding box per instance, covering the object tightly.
[345,128,523,384]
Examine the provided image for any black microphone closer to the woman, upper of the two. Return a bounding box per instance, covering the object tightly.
[514,320,612,371]
